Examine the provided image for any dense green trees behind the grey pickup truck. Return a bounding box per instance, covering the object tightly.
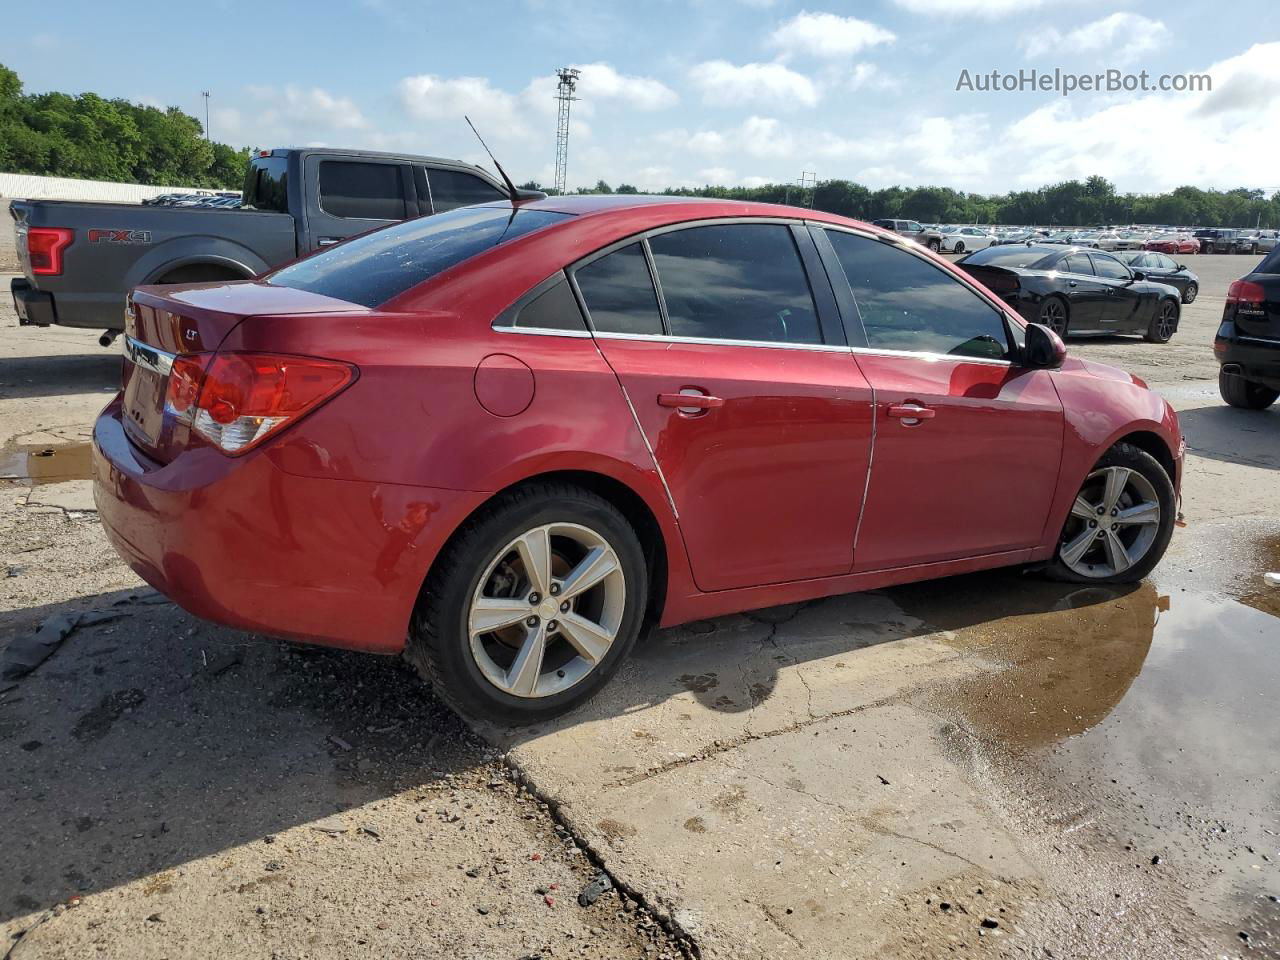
[0,64,248,189]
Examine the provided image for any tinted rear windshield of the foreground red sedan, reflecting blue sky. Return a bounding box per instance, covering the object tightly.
[266,206,571,307]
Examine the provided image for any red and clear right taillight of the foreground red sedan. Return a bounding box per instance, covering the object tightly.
[184,353,356,454]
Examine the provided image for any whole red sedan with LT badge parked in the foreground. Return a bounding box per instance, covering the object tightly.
[93,197,1183,722]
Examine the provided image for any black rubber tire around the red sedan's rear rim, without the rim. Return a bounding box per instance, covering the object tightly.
[404,483,649,726]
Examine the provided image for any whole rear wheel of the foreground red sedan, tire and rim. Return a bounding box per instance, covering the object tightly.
[406,483,649,724]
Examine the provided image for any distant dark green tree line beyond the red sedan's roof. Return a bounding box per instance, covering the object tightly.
[537,177,1280,229]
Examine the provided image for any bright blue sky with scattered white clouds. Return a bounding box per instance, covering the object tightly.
[10,0,1280,193]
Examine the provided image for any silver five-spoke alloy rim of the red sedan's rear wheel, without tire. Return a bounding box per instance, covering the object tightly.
[467,524,626,698]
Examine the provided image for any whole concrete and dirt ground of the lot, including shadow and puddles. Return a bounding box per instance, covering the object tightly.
[0,256,1280,960]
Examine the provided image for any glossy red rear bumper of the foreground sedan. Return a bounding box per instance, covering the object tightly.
[93,398,483,653]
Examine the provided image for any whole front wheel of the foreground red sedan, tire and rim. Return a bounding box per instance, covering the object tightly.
[1046,443,1176,584]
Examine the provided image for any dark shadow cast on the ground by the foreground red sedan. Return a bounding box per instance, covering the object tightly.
[0,571,1156,920]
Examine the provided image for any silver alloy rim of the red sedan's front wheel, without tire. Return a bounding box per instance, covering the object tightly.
[1057,466,1160,579]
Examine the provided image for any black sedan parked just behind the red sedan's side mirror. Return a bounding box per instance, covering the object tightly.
[956,243,1181,343]
